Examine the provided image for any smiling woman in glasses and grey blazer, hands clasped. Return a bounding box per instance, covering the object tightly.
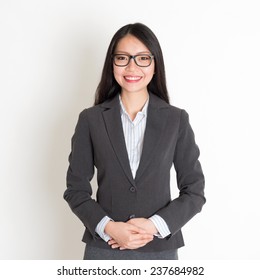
[64,23,205,259]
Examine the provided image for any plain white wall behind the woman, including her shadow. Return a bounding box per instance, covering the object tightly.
[0,0,260,260]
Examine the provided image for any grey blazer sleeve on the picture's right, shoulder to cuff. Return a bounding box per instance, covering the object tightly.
[157,110,206,235]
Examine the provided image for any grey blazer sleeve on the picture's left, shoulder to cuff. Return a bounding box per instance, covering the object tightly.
[64,110,107,238]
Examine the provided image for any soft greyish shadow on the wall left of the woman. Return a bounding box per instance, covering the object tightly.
[42,25,105,259]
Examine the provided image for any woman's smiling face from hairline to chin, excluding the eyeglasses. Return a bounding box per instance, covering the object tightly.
[113,35,155,94]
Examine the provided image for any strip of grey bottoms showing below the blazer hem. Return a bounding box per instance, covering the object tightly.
[84,245,178,260]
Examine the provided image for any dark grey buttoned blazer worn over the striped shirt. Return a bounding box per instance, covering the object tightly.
[64,93,205,252]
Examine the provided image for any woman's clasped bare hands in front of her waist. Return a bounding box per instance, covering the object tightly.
[105,218,157,250]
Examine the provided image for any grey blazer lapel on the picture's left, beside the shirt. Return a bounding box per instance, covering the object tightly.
[101,95,135,186]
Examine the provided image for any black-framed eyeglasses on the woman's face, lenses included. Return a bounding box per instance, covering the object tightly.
[113,54,154,67]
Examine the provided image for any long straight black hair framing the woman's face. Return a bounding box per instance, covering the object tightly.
[95,23,169,105]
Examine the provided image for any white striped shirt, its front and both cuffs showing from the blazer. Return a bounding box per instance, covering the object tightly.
[96,96,171,242]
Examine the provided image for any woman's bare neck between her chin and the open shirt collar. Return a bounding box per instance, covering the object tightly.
[121,91,149,120]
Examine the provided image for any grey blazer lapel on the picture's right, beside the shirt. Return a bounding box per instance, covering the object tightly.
[135,94,169,182]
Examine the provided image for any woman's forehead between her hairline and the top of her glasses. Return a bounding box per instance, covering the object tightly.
[115,34,150,54]
